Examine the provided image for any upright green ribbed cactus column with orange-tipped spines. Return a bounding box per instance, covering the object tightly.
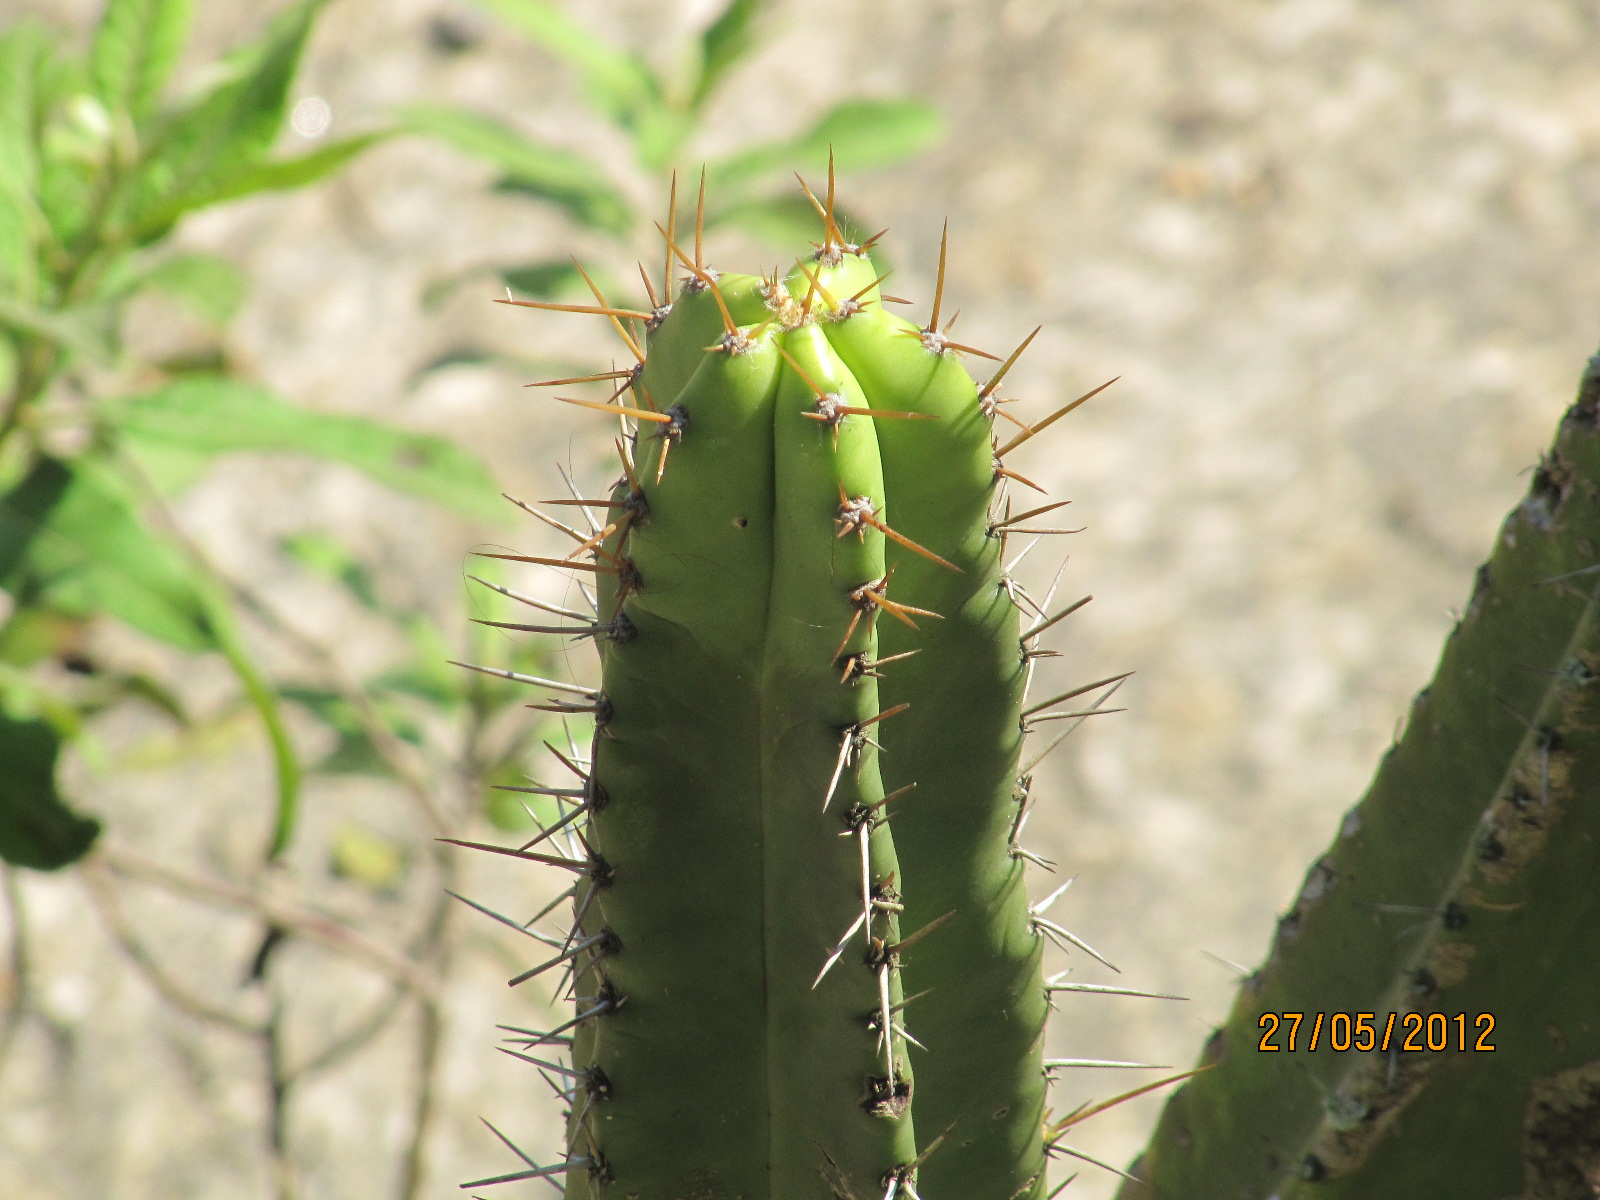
[457,173,1132,1200]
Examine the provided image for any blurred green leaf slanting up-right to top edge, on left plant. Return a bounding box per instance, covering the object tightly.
[126,0,326,243]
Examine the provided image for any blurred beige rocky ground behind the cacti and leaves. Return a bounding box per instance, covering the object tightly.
[0,0,1600,1200]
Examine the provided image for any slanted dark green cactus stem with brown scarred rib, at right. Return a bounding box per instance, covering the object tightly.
[1120,357,1600,1200]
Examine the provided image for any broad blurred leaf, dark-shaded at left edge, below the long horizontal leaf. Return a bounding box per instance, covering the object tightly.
[0,458,216,650]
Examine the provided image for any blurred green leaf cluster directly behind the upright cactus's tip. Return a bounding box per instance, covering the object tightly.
[398,0,944,307]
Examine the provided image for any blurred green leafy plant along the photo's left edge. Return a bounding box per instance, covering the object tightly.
[0,0,556,877]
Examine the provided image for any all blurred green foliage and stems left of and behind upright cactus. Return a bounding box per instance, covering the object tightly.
[0,0,908,1200]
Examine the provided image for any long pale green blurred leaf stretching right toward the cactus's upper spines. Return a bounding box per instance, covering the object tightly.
[110,376,507,523]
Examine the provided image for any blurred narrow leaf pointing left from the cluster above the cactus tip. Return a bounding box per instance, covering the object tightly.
[397,104,634,234]
